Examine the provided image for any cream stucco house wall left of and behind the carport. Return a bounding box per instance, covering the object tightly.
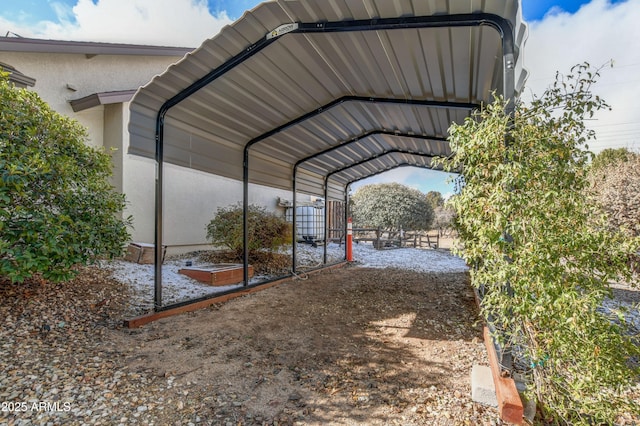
[0,37,302,253]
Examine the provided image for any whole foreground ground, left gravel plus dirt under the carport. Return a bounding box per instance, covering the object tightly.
[0,266,502,426]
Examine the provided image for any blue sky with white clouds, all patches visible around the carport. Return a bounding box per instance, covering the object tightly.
[0,0,640,194]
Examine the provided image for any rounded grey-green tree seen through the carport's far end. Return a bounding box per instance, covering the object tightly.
[351,183,434,231]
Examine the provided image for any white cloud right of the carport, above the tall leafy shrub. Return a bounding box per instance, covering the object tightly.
[524,0,640,151]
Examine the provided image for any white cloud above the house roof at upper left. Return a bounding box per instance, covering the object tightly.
[0,0,232,47]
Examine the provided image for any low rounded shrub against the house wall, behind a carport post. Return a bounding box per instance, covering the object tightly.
[206,204,292,259]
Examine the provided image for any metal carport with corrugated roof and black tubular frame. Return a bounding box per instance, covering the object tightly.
[129,0,526,309]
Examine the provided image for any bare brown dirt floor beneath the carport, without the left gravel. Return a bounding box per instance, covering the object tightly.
[112,267,498,425]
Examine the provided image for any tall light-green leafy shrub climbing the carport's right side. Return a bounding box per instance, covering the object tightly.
[443,65,640,425]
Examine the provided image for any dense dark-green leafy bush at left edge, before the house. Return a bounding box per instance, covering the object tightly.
[0,75,129,282]
